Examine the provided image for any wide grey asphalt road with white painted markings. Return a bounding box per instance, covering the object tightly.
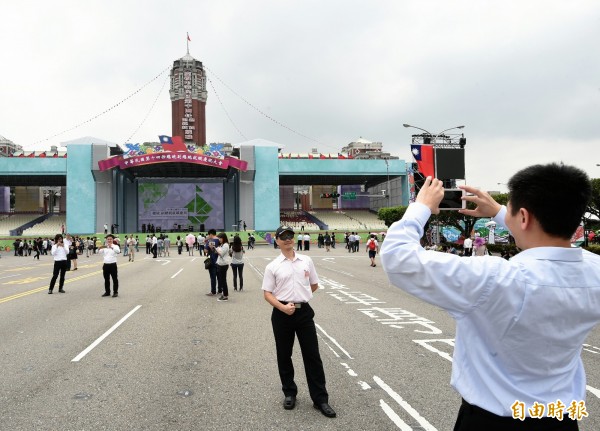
[0,246,600,431]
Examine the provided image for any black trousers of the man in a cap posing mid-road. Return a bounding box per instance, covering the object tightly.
[271,304,329,404]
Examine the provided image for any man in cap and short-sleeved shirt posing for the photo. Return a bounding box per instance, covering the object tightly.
[262,226,336,418]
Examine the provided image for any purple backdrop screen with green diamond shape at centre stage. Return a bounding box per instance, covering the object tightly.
[138,182,225,231]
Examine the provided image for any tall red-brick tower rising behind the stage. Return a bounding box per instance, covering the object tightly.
[169,50,207,146]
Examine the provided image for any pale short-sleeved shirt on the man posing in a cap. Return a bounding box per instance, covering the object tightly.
[262,253,319,302]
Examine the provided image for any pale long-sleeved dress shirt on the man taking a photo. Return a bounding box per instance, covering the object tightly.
[380,203,600,416]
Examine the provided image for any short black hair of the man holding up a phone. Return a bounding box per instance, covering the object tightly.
[508,163,592,239]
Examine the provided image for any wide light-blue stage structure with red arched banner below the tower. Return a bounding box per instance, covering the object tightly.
[0,137,409,234]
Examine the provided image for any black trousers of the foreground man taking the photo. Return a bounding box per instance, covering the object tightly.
[454,400,579,431]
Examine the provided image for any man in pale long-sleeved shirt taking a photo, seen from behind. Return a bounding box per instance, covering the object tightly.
[381,163,600,431]
